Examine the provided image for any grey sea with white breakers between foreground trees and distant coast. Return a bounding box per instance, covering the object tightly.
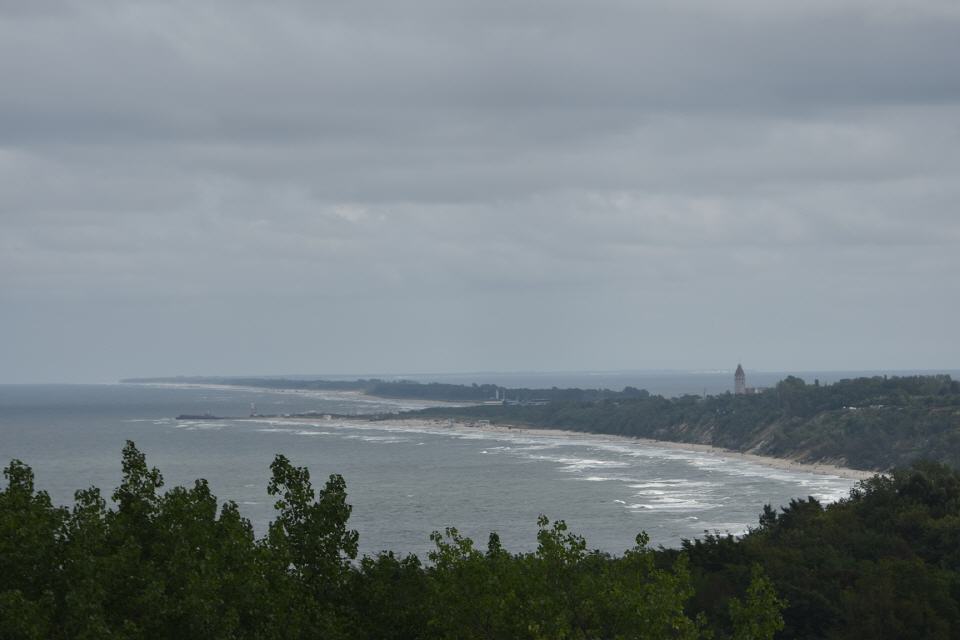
[0,385,853,556]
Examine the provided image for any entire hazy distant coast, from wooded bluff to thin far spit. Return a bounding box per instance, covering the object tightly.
[123,375,960,471]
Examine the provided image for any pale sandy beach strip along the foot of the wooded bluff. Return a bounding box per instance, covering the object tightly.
[296,416,882,480]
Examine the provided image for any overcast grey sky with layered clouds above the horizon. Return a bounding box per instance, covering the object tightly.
[0,0,960,382]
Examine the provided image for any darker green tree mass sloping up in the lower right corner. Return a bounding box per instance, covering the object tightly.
[680,462,960,640]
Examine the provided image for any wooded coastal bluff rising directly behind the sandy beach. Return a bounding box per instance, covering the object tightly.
[417,375,960,470]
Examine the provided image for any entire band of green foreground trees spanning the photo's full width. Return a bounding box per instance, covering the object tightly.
[0,443,960,640]
